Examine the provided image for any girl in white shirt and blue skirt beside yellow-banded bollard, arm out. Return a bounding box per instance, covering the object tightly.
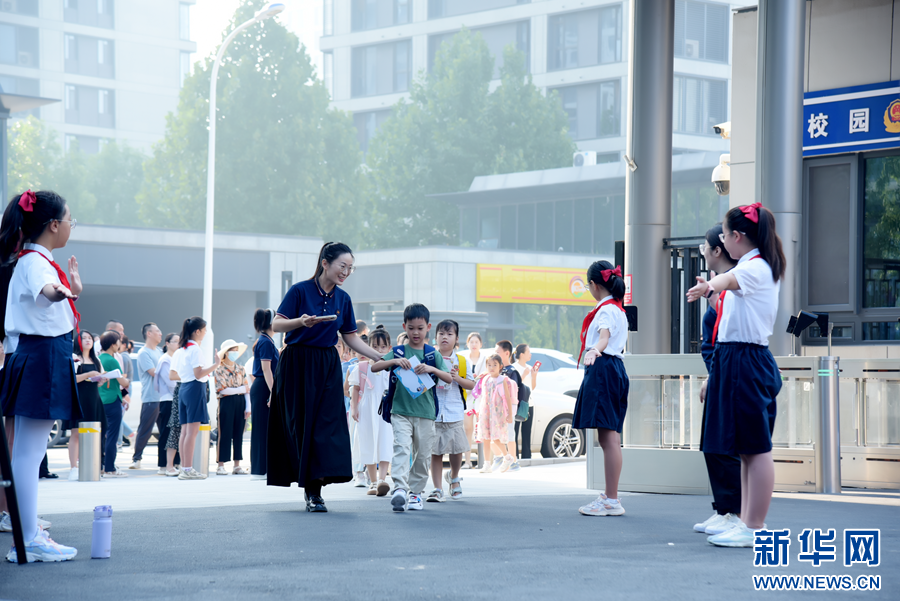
[176,317,220,480]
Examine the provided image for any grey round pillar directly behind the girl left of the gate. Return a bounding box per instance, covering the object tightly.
[625,0,675,354]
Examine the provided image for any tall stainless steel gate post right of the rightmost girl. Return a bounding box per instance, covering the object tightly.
[815,357,841,495]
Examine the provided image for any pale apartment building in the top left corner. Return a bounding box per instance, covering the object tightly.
[0,0,196,153]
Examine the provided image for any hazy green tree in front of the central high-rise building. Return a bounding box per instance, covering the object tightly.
[364,29,575,247]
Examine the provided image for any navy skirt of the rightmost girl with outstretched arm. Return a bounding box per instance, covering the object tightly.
[700,342,781,455]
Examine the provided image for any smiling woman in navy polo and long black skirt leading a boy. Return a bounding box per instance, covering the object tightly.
[267,242,381,512]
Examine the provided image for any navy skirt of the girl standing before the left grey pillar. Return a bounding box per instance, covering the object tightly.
[572,353,629,432]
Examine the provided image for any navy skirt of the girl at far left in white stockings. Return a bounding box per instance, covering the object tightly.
[0,332,82,422]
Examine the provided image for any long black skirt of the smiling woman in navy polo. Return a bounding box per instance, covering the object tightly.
[266,344,353,488]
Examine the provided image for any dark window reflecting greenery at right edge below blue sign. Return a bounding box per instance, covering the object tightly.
[863,156,900,310]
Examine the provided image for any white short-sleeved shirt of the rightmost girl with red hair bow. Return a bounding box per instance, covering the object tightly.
[716,248,781,346]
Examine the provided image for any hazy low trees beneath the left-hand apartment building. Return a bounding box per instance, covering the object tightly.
[9,116,146,226]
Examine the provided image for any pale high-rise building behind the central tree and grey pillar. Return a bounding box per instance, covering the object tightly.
[320,0,740,162]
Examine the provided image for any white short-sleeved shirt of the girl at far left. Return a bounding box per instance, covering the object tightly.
[3,243,75,355]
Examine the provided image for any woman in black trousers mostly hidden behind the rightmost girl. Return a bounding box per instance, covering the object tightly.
[694,223,741,535]
